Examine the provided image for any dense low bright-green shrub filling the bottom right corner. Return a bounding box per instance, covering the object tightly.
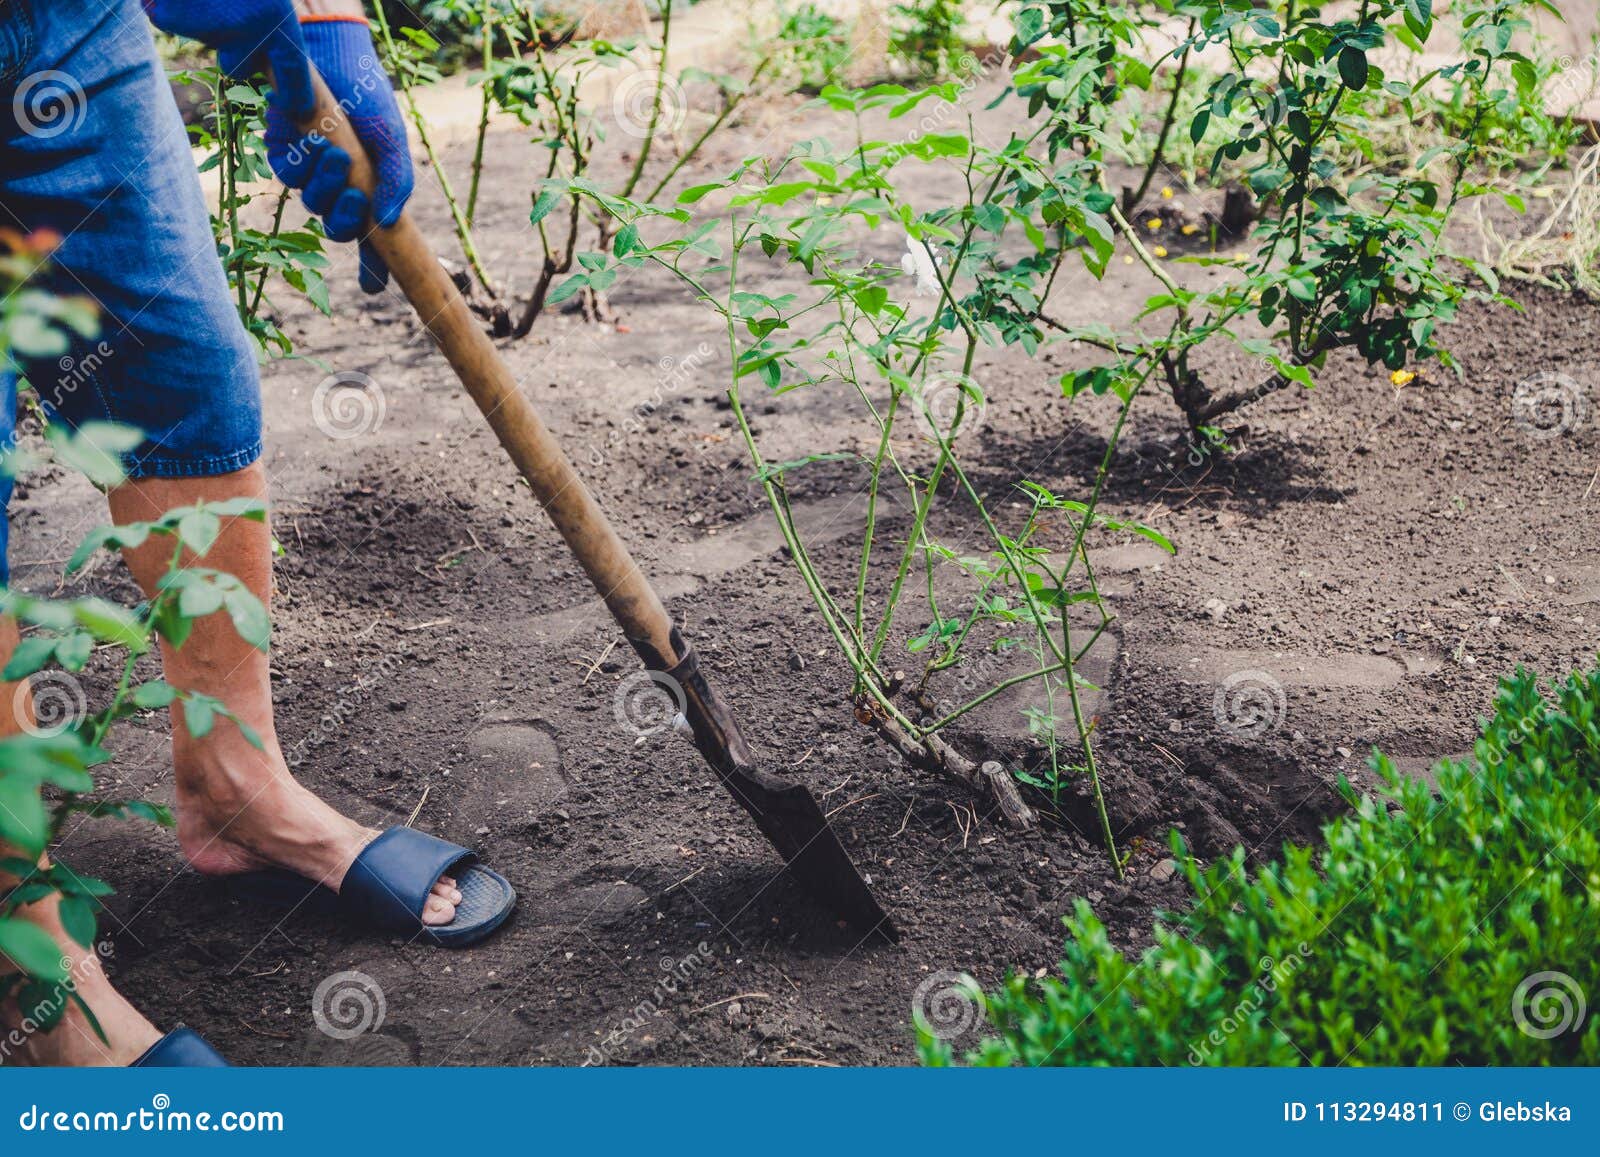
[922,669,1600,1066]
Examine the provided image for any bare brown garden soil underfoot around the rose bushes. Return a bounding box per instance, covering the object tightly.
[13,83,1600,1064]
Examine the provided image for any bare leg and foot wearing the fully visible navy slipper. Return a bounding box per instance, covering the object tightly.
[110,464,461,923]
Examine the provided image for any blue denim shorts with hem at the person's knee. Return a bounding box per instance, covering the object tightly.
[0,0,261,583]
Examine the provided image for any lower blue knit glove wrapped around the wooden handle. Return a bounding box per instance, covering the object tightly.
[266,18,413,293]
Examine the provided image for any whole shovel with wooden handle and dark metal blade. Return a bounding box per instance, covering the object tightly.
[301,72,898,941]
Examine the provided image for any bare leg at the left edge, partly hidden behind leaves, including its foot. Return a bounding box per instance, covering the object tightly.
[0,618,162,1066]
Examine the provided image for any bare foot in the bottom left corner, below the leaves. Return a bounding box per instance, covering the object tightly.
[0,896,162,1067]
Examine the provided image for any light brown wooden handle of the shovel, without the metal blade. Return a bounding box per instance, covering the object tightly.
[301,70,682,671]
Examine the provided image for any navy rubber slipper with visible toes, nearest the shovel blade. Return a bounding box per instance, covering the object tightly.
[227,827,517,947]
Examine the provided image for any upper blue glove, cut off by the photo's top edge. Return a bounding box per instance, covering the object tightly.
[144,0,314,117]
